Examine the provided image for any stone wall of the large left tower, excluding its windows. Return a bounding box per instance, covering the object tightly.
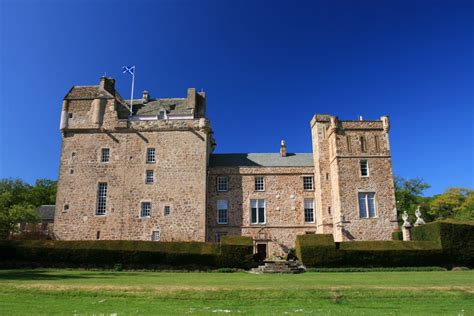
[55,96,209,241]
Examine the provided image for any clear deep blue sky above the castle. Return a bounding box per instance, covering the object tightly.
[0,0,474,194]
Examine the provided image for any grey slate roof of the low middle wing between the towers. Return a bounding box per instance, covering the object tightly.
[209,153,314,167]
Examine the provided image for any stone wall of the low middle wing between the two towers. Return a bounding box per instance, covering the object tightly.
[206,167,314,257]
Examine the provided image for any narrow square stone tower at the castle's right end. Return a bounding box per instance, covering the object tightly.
[311,115,397,241]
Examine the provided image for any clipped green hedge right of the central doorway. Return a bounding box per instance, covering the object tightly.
[296,221,474,268]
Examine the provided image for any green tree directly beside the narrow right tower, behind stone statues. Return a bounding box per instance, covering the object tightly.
[395,177,432,221]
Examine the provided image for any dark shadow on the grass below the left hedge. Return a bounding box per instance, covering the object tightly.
[0,269,143,281]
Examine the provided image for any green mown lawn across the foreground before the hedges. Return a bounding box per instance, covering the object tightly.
[0,270,474,316]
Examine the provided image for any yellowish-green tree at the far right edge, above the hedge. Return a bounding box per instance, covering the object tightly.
[430,187,474,220]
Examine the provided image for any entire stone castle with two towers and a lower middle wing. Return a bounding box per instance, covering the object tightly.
[54,77,397,256]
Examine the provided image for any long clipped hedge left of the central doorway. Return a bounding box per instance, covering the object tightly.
[0,237,253,269]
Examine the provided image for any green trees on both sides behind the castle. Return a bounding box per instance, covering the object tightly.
[0,177,474,239]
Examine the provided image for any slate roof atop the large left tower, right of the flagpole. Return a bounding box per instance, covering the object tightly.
[126,98,194,116]
